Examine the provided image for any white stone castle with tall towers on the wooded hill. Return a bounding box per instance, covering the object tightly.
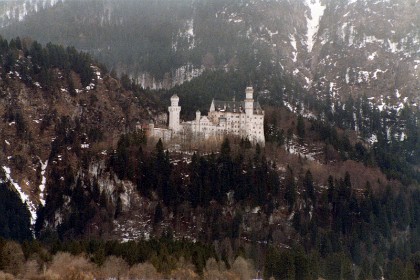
[149,87,265,145]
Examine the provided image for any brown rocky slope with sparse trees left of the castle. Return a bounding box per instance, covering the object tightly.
[0,38,151,230]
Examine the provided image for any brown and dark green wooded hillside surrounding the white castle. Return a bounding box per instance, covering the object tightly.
[0,26,420,279]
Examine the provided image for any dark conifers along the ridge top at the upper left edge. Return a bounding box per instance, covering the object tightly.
[0,37,95,89]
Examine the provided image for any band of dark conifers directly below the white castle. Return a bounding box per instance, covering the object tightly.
[110,136,279,210]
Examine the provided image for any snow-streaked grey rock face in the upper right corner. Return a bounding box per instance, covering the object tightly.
[215,0,420,102]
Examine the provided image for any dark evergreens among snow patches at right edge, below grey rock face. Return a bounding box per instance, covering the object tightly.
[300,94,420,185]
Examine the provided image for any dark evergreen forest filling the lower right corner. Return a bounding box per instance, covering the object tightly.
[264,173,420,279]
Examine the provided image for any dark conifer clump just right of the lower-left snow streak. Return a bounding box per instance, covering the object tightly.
[35,162,110,240]
